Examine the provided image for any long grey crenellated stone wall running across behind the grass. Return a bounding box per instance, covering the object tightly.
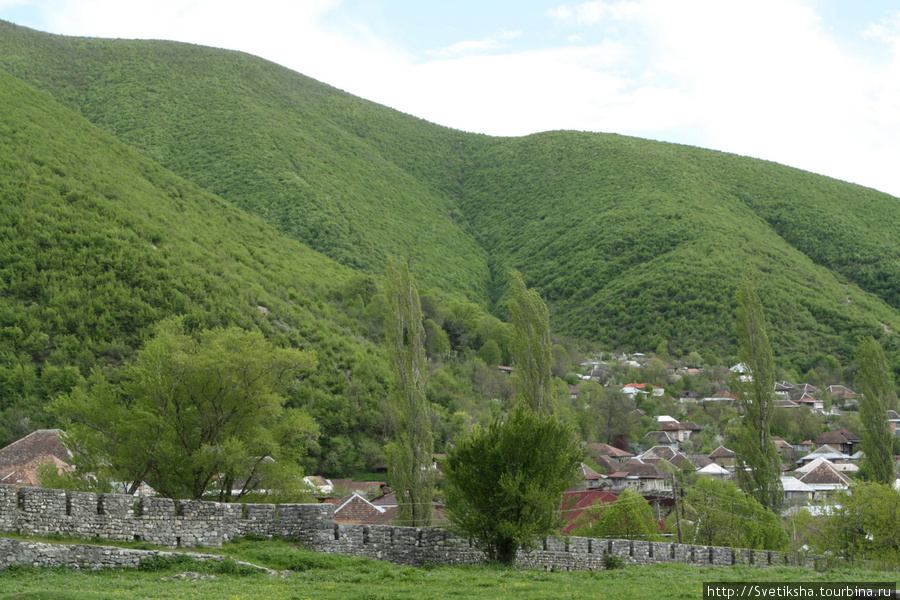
[0,485,793,570]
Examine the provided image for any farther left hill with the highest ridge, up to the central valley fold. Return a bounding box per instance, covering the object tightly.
[0,22,488,300]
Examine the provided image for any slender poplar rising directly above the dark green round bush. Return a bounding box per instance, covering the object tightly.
[509,271,553,413]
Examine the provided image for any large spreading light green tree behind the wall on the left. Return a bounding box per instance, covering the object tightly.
[50,320,318,501]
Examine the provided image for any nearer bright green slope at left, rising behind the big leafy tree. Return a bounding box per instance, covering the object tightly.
[0,71,388,445]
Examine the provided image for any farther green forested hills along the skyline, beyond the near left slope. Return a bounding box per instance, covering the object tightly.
[0,22,900,370]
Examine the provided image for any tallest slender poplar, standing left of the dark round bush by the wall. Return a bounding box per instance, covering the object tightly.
[385,261,434,527]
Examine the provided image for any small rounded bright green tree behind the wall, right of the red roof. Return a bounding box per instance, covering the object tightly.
[572,490,662,542]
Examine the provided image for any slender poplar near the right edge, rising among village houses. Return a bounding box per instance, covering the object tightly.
[856,336,896,483]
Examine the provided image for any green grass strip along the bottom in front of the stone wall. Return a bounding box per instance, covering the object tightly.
[0,542,893,600]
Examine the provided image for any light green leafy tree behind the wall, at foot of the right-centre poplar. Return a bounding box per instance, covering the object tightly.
[683,477,788,550]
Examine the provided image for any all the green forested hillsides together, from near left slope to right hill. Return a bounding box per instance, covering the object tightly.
[0,21,900,474]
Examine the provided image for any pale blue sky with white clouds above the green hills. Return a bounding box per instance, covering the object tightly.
[0,0,900,197]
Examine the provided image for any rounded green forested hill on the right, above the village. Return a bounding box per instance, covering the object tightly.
[462,132,900,366]
